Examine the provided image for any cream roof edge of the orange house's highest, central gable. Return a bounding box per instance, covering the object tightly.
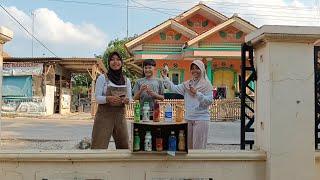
[174,3,228,23]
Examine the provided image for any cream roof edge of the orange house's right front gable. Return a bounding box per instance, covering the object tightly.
[187,15,257,46]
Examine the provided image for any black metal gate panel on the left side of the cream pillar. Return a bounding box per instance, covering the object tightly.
[240,43,257,150]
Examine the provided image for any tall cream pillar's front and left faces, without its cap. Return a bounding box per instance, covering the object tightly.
[255,42,314,180]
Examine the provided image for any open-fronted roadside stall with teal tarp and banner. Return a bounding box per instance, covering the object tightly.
[1,57,106,115]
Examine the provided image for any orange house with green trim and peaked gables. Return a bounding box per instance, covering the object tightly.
[125,3,256,98]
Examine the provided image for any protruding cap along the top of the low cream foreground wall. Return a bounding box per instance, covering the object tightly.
[0,150,266,162]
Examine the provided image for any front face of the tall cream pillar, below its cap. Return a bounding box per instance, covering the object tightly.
[267,42,315,180]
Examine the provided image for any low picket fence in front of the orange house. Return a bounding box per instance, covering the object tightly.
[126,99,253,121]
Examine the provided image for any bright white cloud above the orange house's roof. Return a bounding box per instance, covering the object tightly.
[139,0,320,27]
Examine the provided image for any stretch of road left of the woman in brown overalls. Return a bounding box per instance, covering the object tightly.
[1,114,93,140]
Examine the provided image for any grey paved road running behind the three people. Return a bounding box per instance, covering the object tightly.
[1,113,254,150]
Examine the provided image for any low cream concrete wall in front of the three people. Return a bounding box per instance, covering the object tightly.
[0,151,265,180]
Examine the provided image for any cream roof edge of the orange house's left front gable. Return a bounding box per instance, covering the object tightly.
[125,19,198,49]
